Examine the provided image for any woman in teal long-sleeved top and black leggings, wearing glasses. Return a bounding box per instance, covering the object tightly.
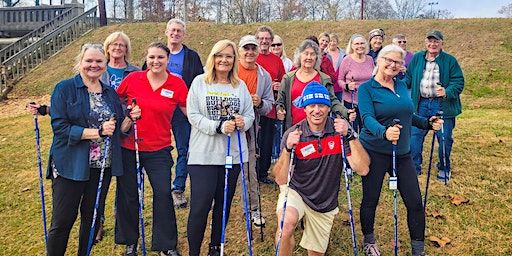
[358,45,443,256]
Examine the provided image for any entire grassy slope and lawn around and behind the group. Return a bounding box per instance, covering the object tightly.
[0,19,512,256]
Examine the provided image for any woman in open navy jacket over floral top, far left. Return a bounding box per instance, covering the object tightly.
[47,44,140,256]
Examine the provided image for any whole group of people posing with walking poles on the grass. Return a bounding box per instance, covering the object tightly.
[30,19,464,256]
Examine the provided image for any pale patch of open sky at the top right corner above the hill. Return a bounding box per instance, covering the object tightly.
[436,0,512,18]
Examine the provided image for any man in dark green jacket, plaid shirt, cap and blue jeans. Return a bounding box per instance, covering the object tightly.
[405,30,464,181]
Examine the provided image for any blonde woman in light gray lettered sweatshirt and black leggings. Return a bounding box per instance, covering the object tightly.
[187,40,254,256]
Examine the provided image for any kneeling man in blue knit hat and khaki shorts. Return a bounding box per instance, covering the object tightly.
[274,82,357,255]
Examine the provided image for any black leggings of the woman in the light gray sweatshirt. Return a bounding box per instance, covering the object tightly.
[187,165,240,256]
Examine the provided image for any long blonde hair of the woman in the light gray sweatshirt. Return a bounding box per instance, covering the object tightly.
[204,39,240,87]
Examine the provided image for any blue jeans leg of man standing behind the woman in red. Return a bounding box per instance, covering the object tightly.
[171,108,190,191]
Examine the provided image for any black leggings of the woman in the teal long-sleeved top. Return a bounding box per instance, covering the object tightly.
[360,149,425,241]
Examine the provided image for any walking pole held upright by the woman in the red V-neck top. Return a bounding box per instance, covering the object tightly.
[132,98,147,256]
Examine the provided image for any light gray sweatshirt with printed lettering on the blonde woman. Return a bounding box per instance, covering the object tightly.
[187,75,254,165]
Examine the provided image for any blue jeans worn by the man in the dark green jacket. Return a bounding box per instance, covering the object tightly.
[411,98,455,174]
